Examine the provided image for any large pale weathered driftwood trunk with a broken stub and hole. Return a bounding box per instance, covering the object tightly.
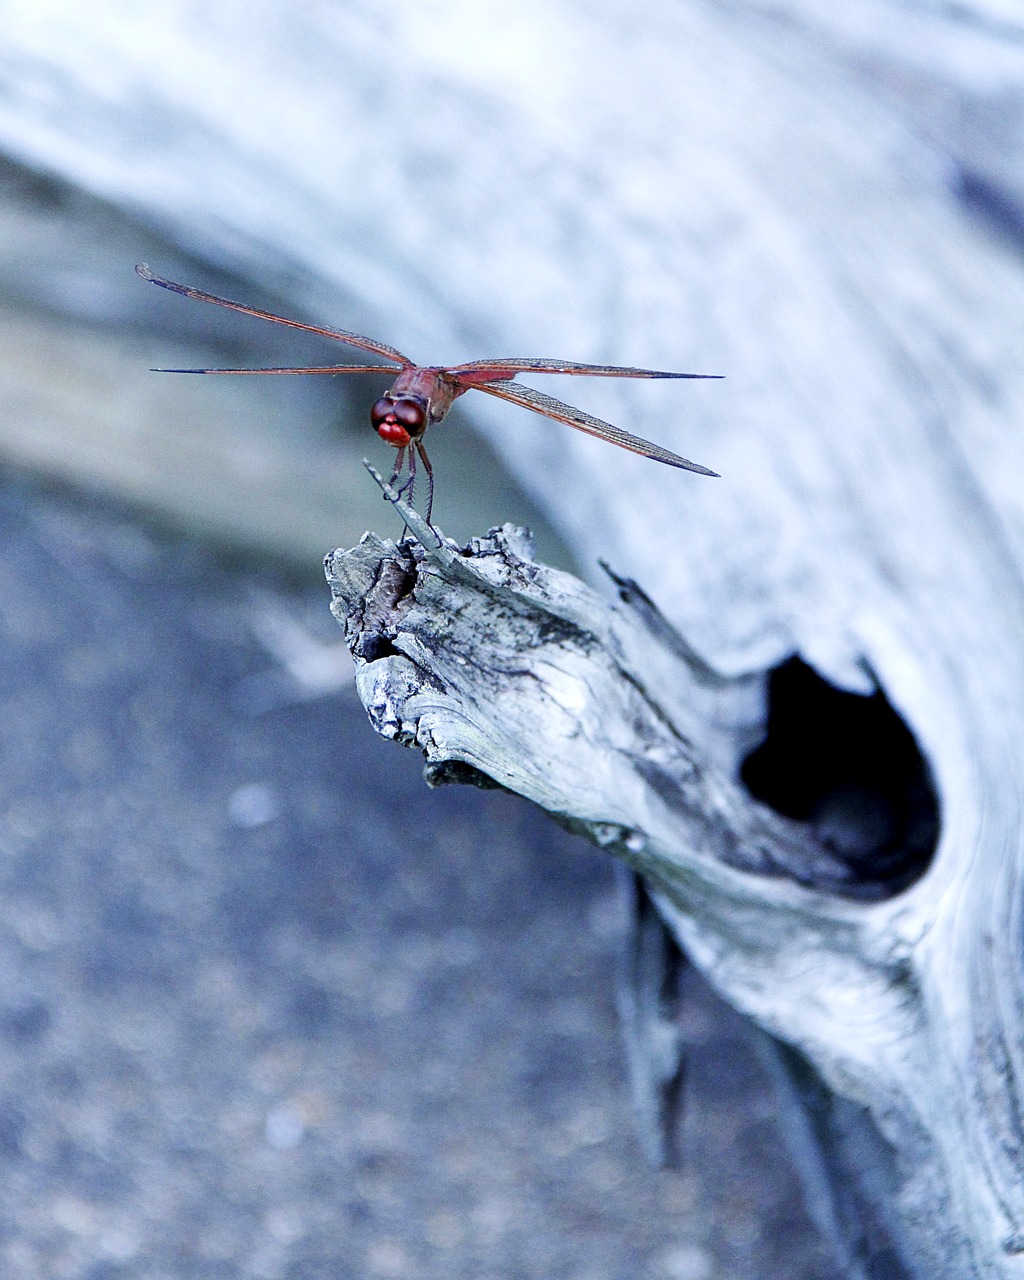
[0,0,1024,1280]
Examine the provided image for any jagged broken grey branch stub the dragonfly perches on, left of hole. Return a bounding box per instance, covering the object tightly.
[328,478,878,897]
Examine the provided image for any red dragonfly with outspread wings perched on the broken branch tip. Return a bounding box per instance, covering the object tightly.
[136,264,722,524]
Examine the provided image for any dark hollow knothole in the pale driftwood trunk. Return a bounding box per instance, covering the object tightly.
[740,658,940,893]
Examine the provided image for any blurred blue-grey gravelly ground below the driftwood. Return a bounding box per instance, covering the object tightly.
[0,479,832,1280]
